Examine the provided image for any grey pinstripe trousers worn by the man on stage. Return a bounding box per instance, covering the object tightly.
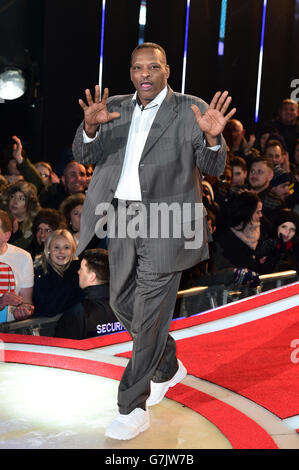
[108,200,181,414]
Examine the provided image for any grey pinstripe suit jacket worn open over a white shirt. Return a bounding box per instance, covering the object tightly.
[73,88,226,273]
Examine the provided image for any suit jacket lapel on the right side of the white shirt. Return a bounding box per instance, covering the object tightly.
[140,88,177,161]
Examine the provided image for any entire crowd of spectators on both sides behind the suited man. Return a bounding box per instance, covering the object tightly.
[0,99,299,339]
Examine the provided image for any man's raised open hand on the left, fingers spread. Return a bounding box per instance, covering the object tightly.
[79,85,120,137]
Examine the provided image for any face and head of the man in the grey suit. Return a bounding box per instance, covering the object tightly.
[130,48,169,106]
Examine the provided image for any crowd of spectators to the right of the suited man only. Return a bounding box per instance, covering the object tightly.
[182,99,299,288]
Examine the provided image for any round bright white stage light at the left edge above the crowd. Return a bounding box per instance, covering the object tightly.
[0,67,26,100]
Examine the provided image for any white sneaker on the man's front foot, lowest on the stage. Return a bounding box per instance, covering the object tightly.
[105,408,150,441]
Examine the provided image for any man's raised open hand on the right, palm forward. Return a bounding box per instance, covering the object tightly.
[191,91,236,147]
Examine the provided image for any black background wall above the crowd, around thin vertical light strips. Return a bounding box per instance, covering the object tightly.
[0,0,299,168]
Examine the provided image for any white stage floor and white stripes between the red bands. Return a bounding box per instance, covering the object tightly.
[0,282,299,449]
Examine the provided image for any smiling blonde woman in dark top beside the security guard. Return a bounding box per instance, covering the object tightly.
[33,229,83,317]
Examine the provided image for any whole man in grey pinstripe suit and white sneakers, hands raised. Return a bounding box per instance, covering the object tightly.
[73,43,235,439]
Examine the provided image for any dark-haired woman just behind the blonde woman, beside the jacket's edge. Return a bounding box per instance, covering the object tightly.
[59,193,85,245]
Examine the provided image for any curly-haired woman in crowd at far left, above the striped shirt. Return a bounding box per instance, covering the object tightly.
[1,181,40,250]
